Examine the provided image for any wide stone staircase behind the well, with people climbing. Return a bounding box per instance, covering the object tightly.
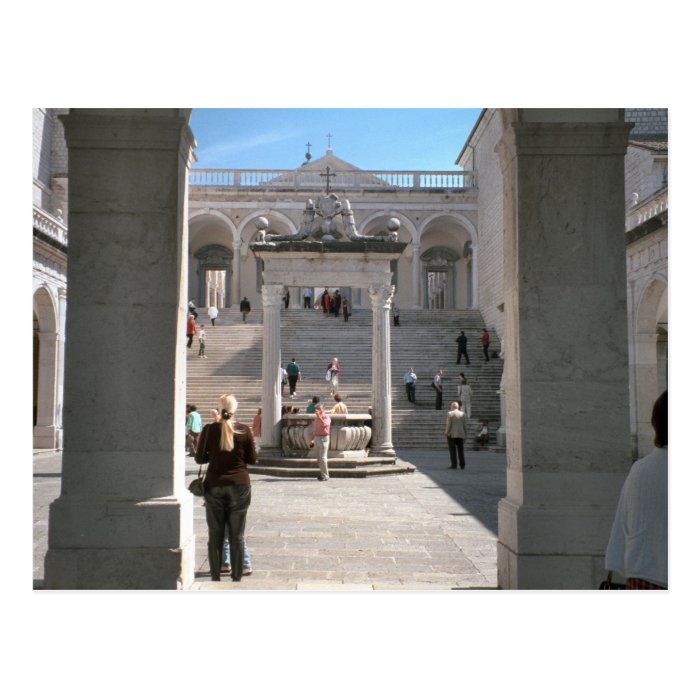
[187,309,503,449]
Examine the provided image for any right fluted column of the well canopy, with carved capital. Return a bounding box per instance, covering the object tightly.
[369,284,396,457]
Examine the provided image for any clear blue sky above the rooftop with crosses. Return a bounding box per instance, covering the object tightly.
[190,108,481,170]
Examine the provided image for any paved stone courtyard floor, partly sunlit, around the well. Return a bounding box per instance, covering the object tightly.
[34,448,506,591]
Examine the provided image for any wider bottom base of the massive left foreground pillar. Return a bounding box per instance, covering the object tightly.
[43,494,195,590]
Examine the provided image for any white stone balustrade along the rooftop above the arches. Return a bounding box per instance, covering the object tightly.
[190,168,476,190]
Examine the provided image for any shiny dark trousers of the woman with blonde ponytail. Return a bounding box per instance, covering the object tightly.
[204,485,251,581]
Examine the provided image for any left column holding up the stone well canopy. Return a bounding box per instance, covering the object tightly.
[260,284,284,453]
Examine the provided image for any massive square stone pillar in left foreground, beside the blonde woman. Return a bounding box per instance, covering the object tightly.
[44,109,194,589]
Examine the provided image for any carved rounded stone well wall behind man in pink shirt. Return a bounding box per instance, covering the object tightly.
[282,413,372,459]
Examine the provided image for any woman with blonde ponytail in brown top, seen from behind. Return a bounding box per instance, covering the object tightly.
[195,394,257,581]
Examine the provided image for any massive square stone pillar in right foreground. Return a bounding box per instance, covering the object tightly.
[498,110,630,589]
